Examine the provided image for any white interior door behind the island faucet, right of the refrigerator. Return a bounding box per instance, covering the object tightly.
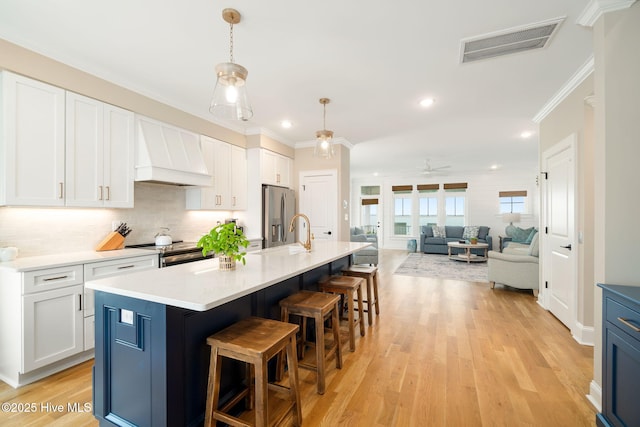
[297,170,338,240]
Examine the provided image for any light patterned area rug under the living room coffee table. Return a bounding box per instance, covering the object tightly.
[394,253,489,282]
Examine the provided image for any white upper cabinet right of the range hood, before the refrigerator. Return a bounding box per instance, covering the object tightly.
[186,135,247,210]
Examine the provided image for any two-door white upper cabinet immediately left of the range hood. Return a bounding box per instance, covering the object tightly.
[65,92,134,208]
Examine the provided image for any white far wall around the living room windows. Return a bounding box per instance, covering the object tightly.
[351,168,540,249]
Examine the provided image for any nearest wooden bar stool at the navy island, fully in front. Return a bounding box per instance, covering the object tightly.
[204,317,302,427]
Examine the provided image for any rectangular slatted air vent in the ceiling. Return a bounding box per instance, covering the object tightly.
[461,17,565,62]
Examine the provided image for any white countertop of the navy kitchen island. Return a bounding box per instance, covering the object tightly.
[85,240,370,311]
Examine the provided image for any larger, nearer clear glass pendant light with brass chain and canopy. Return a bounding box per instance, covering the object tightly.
[209,9,253,121]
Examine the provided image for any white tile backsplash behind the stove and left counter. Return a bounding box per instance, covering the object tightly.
[0,182,254,257]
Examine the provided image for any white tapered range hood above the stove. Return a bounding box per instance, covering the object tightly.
[135,116,211,186]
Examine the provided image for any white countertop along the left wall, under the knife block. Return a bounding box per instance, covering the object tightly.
[0,249,154,272]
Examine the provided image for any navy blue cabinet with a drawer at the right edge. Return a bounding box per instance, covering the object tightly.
[596,284,640,427]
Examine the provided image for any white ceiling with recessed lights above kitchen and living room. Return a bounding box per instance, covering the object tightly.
[0,0,592,177]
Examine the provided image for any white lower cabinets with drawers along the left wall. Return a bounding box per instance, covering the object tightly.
[0,253,158,387]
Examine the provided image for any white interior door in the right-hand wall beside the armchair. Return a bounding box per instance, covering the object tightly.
[543,135,577,330]
